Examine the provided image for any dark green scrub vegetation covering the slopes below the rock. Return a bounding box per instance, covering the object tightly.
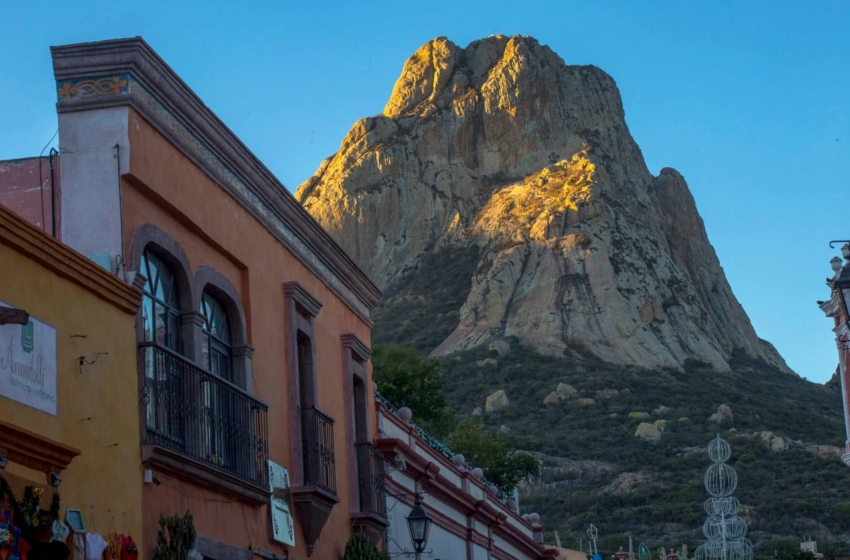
[374,249,850,553]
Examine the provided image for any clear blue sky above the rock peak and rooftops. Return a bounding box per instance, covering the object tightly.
[0,0,850,382]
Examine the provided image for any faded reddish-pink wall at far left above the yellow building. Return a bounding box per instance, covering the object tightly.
[0,156,59,235]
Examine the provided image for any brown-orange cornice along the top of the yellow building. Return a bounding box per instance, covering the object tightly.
[0,206,142,315]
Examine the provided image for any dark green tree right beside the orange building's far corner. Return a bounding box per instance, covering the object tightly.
[372,344,454,437]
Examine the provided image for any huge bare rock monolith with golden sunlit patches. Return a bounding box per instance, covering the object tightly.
[296,36,790,371]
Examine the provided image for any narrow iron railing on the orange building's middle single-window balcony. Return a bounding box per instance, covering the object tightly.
[301,406,336,494]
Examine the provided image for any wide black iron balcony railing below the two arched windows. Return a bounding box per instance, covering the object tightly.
[139,343,268,486]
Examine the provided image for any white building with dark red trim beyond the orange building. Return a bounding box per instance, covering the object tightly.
[375,399,558,560]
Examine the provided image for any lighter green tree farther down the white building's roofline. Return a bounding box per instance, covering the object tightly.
[448,416,540,494]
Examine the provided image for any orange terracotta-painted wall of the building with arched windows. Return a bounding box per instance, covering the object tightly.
[123,110,375,559]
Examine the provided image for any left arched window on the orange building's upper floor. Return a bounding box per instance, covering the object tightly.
[140,249,181,352]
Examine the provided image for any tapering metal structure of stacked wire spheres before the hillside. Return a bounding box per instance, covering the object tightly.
[694,435,753,560]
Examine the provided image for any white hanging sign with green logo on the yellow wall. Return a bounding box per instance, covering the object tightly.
[0,301,56,416]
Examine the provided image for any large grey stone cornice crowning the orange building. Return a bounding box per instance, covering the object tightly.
[51,37,381,322]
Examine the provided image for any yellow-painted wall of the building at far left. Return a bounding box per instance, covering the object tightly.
[0,240,142,545]
